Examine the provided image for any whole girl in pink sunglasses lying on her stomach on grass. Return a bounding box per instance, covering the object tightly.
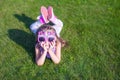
[30,6,64,66]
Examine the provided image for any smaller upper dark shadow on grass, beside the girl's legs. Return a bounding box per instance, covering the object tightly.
[14,14,35,28]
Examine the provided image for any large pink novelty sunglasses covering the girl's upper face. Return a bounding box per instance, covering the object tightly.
[38,30,56,43]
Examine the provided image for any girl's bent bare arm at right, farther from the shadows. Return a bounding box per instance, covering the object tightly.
[49,41,61,64]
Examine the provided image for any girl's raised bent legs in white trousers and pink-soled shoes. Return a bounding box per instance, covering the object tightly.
[30,6,63,37]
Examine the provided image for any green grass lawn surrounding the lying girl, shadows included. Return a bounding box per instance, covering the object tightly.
[0,0,120,80]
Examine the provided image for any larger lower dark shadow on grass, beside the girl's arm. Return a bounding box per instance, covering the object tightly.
[8,29,35,62]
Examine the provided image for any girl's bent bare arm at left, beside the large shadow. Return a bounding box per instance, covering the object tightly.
[35,43,47,66]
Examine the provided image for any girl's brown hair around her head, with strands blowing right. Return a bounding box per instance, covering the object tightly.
[36,24,66,47]
